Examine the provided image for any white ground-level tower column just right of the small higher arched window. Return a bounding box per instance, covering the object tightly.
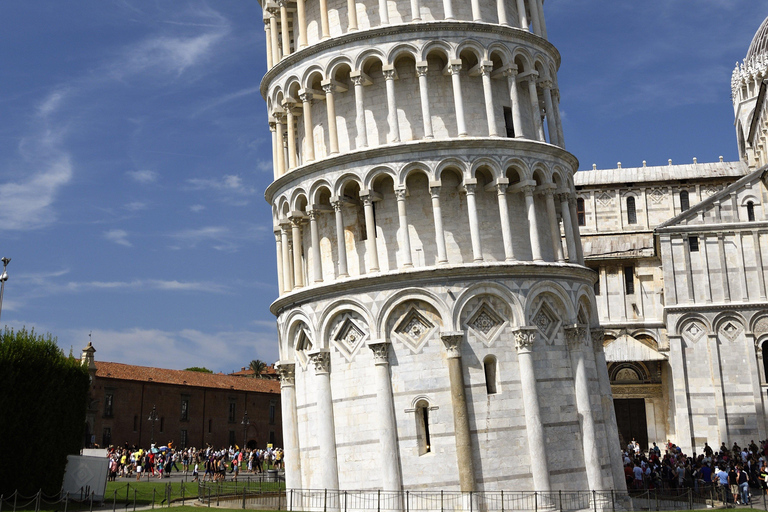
[515,327,551,493]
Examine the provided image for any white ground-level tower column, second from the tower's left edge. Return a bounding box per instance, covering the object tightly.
[307,349,339,494]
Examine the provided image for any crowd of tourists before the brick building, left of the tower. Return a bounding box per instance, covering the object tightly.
[107,443,283,482]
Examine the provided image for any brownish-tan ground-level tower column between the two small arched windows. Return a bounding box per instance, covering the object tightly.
[440,331,476,492]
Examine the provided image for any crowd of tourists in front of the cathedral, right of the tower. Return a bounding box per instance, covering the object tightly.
[623,439,768,505]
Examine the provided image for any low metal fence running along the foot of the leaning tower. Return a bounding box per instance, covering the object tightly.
[198,484,752,512]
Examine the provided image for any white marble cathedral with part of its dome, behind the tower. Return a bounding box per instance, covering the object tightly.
[574,15,768,453]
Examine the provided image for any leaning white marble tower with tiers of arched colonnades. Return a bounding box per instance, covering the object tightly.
[261,0,624,491]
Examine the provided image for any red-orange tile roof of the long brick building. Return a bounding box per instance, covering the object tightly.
[96,361,280,393]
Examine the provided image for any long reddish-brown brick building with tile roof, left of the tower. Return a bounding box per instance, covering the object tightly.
[82,343,283,448]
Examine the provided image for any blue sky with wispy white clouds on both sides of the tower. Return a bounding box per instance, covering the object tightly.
[0,0,768,371]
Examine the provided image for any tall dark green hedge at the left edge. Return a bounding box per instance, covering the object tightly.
[0,327,89,496]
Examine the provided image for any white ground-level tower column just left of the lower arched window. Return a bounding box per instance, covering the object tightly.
[368,340,403,492]
